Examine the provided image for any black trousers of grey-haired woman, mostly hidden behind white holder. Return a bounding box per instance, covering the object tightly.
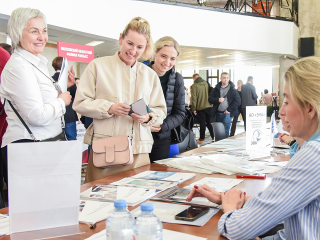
[0,139,33,208]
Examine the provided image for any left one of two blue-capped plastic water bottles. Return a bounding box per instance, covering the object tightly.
[106,200,134,240]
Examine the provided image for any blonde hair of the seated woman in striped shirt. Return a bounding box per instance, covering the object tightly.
[285,57,320,129]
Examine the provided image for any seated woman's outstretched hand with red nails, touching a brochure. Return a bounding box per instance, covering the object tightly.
[186,184,221,204]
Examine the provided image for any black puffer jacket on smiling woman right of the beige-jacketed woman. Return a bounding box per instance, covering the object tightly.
[148,62,185,139]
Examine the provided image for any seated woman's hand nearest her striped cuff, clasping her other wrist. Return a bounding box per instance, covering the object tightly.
[221,188,246,212]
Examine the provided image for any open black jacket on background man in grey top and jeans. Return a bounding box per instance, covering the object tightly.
[209,81,241,117]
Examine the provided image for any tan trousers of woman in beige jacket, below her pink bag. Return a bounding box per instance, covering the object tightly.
[85,149,150,183]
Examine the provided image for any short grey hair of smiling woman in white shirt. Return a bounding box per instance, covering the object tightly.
[8,8,47,49]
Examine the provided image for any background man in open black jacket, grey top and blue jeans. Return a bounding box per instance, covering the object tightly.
[209,72,241,137]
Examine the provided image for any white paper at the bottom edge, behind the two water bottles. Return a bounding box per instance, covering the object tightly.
[85,229,207,240]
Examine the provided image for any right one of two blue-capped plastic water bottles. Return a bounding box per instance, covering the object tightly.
[133,202,162,240]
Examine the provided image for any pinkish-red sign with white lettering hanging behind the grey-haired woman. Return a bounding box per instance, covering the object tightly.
[58,42,94,63]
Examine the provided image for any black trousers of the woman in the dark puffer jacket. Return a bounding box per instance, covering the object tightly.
[149,136,171,163]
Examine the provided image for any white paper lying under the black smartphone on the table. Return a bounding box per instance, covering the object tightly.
[131,202,219,226]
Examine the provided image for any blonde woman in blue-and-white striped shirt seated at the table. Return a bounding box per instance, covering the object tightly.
[187,57,320,240]
